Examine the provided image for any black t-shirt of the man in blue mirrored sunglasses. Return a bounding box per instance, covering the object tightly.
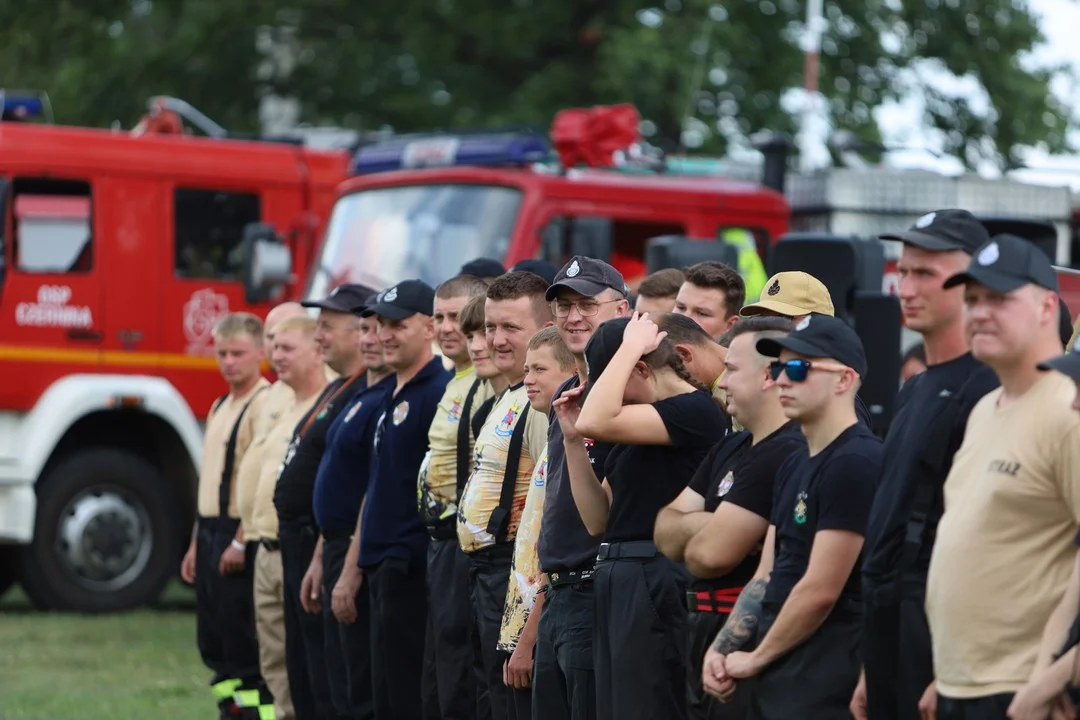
[765,422,885,609]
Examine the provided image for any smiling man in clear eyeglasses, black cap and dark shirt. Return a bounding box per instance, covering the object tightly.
[532,256,630,720]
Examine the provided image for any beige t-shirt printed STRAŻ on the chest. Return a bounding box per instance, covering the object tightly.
[927,372,1080,698]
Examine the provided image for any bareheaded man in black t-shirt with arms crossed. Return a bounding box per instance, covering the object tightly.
[654,317,806,720]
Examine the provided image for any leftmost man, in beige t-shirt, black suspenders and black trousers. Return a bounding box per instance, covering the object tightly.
[180,313,270,718]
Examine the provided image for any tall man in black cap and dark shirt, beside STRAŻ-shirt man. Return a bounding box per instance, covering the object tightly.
[851,209,998,720]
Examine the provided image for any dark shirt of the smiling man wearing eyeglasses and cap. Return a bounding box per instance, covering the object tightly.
[537,375,612,573]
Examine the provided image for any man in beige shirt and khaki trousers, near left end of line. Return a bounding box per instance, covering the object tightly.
[251,314,327,720]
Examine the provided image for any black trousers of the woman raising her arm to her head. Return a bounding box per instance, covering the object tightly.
[593,543,689,720]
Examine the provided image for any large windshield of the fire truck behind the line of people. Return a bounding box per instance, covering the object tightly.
[307,185,522,298]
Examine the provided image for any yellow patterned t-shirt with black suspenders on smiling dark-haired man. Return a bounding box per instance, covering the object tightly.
[458,384,548,553]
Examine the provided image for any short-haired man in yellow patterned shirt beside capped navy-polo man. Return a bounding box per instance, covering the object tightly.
[417,275,495,718]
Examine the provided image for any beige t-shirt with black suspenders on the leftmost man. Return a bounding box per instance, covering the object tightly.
[198,378,270,517]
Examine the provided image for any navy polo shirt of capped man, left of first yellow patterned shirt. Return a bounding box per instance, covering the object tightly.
[359,357,454,567]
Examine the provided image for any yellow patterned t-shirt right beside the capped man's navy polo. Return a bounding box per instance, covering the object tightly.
[417,367,494,519]
